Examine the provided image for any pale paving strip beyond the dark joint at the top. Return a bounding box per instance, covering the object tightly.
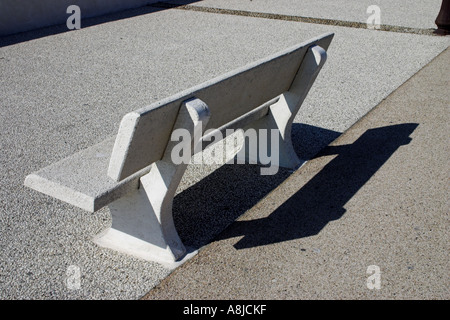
[166,0,442,29]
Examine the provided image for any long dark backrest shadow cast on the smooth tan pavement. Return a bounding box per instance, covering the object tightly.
[211,123,418,249]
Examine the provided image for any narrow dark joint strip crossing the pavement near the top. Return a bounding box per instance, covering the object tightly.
[150,2,439,35]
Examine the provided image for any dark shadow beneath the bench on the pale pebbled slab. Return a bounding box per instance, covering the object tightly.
[173,123,340,248]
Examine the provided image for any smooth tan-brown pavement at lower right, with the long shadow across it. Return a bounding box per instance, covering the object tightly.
[144,49,450,300]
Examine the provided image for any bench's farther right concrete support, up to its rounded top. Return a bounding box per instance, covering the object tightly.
[237,45,327,175]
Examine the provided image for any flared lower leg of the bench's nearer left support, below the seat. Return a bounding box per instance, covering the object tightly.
[94,161,192,265]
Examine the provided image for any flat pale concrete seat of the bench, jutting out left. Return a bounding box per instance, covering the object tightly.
[25,137,150,212]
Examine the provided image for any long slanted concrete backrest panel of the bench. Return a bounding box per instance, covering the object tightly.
[108,34,332,181]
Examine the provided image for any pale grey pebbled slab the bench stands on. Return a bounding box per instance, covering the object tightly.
[0,8,448,299]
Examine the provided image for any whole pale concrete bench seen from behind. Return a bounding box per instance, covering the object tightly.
[25,34,333,266]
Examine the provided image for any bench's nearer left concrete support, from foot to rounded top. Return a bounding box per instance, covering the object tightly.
[94,98,210,268]
